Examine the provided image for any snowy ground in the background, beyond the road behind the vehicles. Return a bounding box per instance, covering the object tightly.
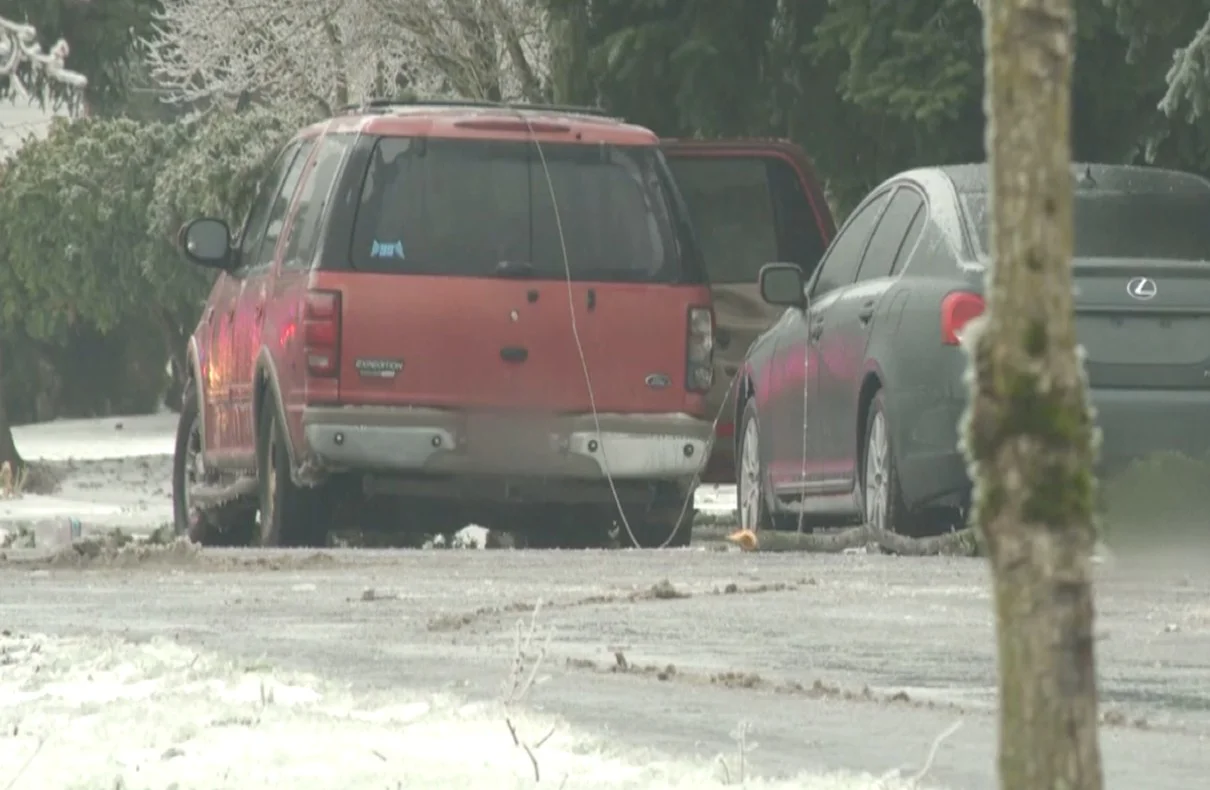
[0,414,736,535]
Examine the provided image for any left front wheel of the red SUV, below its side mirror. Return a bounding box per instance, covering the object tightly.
[172,382,257,546]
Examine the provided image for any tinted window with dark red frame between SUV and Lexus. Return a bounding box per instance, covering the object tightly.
[668,155,824,283]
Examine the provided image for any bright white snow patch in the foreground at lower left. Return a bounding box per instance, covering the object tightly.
[0,636,934,790]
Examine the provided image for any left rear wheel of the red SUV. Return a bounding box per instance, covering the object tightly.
[257,406,332,547]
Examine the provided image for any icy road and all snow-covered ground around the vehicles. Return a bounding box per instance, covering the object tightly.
[0,415,1210,790]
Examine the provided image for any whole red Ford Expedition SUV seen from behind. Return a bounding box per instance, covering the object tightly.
[173,103,714,546]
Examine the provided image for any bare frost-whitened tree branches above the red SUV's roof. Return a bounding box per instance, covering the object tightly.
[146,0,549,111]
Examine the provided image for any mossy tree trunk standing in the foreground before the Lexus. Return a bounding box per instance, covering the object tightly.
[964,0,1102,790]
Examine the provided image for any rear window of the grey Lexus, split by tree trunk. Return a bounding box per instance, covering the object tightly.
[962,190,1210,260]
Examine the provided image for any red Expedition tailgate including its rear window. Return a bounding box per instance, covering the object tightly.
[317,134,710,416]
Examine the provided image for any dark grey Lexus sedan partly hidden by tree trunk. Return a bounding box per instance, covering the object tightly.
[734,163,1210,535]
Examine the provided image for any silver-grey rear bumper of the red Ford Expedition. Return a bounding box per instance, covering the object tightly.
[303,406,713,480]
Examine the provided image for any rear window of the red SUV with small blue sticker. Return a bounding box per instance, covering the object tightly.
[351,137,702,283]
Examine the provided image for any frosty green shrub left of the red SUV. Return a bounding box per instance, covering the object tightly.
[0,109,306,419]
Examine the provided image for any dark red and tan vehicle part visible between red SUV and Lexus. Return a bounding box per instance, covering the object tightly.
[662,140,836,482]
